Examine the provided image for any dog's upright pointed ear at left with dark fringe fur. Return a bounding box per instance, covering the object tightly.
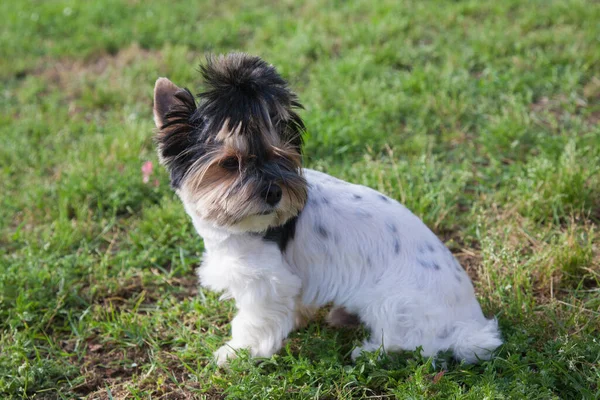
[154,78,196,164]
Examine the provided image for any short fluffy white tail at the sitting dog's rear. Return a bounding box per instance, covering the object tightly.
[452,318,502,364]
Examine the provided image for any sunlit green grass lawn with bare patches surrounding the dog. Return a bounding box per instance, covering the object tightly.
[0,0,600,399]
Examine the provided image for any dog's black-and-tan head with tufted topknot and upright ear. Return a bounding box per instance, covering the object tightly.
[154,53,307,232]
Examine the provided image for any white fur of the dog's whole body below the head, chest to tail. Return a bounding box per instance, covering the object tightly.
[180,169,502,364]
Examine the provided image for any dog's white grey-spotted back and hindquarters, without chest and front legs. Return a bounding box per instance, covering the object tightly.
[285,169,501,362]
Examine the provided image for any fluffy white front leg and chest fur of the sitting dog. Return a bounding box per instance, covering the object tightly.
[198,238,306,365]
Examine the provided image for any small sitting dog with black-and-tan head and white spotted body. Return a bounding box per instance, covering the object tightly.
[154,53,502,365]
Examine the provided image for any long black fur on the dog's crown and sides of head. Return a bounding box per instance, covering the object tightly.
[157,53,305,188]
